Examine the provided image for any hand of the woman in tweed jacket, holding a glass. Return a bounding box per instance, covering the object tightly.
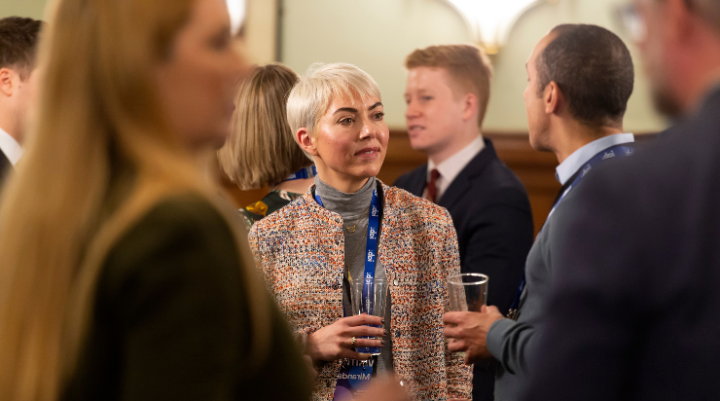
[307,314,385,362]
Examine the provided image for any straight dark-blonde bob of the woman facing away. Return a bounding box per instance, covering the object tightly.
[218,64,312,190]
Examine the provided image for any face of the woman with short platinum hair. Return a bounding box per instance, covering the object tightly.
[311,92,389,192]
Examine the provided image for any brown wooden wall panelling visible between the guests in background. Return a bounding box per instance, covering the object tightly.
[222,131,654,238]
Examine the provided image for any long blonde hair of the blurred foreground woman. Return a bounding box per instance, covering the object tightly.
[0,0,269,401]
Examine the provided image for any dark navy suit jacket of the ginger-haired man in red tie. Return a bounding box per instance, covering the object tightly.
[395,139,534,401]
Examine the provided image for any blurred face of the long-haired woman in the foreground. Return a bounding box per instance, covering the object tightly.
[157,0,247,150]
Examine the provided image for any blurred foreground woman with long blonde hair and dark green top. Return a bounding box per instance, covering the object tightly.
[0,0,311,401]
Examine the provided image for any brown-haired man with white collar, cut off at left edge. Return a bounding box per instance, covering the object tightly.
[0,17,42,183]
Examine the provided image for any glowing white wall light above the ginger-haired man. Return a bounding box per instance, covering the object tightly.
[446,0,557,54]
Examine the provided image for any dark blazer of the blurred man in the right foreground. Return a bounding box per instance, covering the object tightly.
[525,91,720,401]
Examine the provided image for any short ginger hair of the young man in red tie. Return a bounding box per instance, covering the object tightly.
[405,45,493,127]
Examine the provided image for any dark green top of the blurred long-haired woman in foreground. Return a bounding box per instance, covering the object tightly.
[62,195,311,401]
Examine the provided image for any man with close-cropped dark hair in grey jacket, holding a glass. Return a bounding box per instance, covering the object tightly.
[444,24,635,401]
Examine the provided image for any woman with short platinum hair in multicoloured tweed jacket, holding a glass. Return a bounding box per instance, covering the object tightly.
[249,64,472,400]
